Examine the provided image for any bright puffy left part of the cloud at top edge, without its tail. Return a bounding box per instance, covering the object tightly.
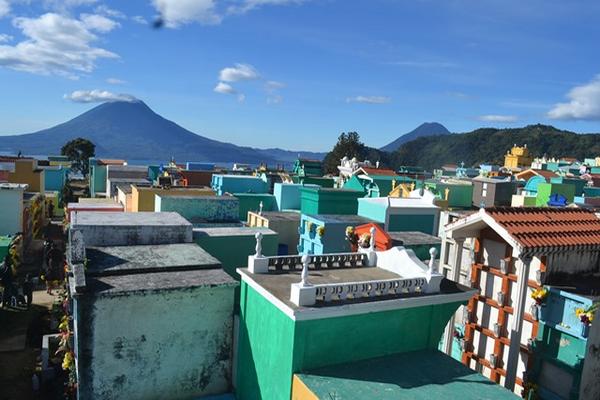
[152,0,222,28]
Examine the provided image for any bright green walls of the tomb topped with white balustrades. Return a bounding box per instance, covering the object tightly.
[236,282,461,400]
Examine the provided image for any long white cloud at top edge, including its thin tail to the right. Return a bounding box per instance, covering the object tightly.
[152,0,306,28]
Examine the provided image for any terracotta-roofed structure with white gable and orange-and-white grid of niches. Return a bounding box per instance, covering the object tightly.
[440,207,600,393]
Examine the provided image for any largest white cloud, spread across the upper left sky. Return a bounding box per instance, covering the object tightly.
[0,13,118,78]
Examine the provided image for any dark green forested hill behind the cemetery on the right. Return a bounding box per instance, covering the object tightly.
[388,124,600,170]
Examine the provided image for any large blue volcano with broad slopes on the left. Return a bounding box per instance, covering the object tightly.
[0,101,325,164]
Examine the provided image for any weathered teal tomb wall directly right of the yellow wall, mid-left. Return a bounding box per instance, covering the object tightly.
[154,195,240,223]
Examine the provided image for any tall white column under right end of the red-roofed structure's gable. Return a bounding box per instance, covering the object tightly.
[504,254,531,391]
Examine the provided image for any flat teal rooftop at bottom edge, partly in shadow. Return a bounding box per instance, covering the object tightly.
[296,350,518,400]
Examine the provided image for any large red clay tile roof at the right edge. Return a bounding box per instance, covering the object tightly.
[485,207,600,249]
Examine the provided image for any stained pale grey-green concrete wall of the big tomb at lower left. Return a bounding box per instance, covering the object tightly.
[78,286,234,400]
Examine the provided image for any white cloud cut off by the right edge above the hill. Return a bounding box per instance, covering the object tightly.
[548,75,600,120]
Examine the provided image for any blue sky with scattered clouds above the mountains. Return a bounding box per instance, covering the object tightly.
[0,0,600,151]
